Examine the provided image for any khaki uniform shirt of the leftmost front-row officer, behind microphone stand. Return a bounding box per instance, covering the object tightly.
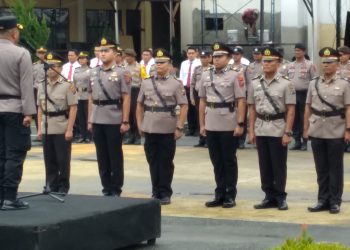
[37,77,78,134]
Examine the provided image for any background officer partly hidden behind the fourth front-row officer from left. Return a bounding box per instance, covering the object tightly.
[190,51,212,147]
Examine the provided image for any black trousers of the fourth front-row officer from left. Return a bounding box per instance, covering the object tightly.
[207,131,238,199]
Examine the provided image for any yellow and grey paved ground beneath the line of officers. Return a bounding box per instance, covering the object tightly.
[20,133,350,249]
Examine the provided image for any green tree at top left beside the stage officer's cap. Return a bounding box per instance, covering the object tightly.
[7,0,50,51]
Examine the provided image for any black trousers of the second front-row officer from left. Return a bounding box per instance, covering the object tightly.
[92,123,124,195]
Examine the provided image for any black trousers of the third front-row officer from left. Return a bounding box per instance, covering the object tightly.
[144,133,176,198]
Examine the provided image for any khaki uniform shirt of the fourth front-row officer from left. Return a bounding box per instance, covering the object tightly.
[199,66,246,131]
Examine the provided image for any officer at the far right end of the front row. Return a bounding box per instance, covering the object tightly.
[304,47,350,214]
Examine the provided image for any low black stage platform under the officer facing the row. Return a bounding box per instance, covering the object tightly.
[0,195,161,250]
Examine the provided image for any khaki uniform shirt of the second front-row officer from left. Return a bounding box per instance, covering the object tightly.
[88,65,130,124]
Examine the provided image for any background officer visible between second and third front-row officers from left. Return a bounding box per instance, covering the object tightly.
[124,49,141,145]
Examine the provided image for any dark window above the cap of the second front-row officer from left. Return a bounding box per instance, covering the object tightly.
[86,10,122,43]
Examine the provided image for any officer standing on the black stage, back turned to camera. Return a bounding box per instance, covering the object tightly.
[0,16,36,210]
